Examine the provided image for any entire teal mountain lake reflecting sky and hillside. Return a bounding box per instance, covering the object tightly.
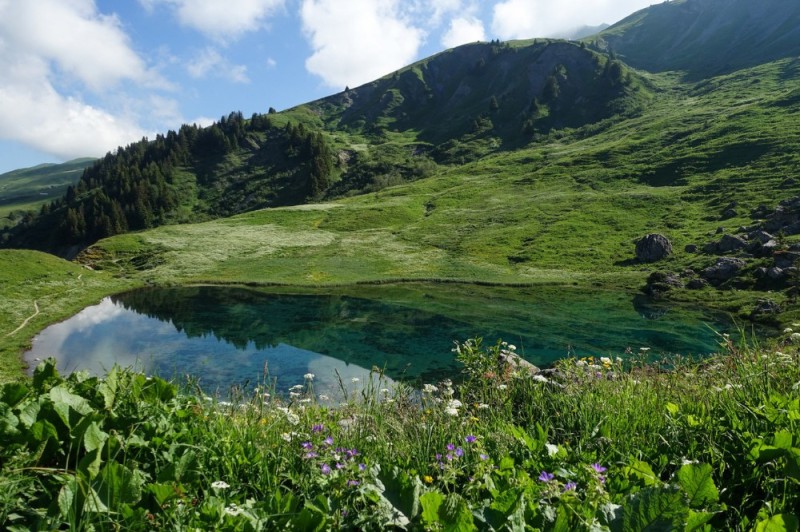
[25,284,730,393]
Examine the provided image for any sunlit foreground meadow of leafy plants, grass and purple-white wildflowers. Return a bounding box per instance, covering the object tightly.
[0,334,800,531]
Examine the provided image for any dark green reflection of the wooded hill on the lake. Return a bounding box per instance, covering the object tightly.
[108,287,468,377]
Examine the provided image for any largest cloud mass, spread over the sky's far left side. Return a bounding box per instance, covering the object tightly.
[0,0,161,158]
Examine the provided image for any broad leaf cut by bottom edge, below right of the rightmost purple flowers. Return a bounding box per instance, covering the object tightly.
[621,487,689,532]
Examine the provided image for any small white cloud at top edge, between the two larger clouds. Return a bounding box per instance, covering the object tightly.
[145,0,285,41]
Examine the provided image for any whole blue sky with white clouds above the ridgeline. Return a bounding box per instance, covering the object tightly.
[0,0,651,173]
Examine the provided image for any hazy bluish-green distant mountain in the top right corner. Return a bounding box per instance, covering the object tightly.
[588,0,800,79]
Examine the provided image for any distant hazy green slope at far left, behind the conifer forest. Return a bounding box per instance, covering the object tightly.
[0,158,94,227]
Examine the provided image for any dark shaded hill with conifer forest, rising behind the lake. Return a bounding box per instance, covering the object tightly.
[0,39,640,255]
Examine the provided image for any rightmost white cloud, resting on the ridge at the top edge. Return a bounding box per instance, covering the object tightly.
[492,0,653,39]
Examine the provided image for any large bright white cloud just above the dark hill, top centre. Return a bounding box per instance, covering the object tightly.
[301,0,424,88]
